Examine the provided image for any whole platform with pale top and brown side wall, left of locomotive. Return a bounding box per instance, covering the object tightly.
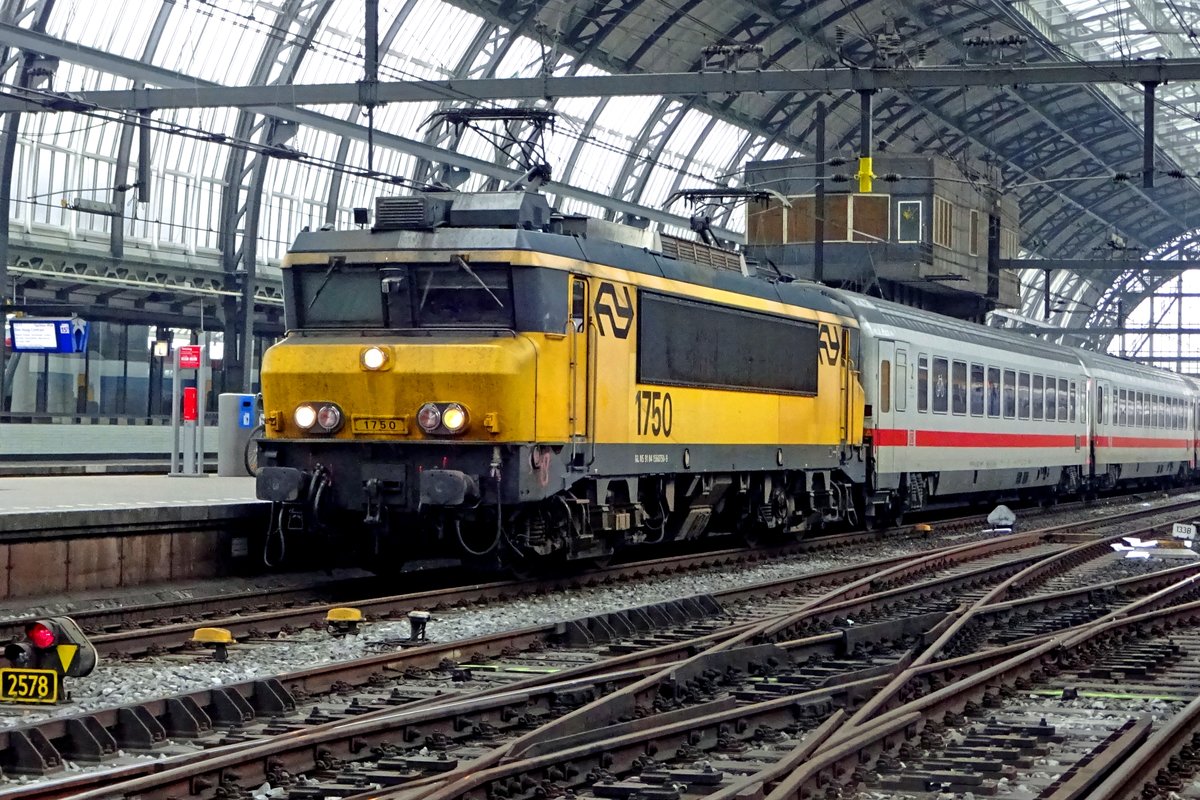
[0,475,270,599]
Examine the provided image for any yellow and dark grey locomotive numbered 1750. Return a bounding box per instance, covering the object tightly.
[258,191,868,566]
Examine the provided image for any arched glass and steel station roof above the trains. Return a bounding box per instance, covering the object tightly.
[0,0,1200,340]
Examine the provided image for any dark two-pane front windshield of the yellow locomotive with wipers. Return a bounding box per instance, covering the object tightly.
[293,255,514,330]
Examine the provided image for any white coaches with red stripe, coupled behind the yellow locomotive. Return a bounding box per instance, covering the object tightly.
[830,290,1196,510]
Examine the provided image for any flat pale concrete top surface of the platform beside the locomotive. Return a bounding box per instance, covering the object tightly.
[0,475,258,517]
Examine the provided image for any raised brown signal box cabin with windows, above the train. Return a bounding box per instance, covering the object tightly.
[745,154,1020,320]
